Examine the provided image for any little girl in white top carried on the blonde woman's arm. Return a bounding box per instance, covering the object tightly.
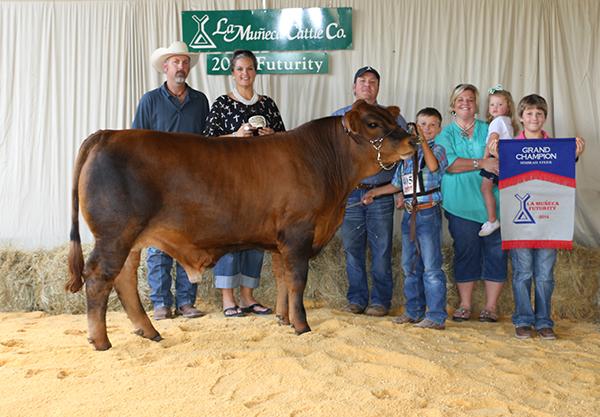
[479,84,518,237]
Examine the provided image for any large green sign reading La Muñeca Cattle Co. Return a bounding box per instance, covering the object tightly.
[181,7,352,52]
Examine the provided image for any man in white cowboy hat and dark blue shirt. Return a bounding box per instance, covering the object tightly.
[132,42,209,320]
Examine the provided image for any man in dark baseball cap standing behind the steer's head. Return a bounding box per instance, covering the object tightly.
[333,66,406,316]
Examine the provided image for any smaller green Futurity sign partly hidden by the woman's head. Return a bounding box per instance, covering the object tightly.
[206,52,329,75]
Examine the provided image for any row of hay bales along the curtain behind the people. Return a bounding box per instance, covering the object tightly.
[0,237,600,320]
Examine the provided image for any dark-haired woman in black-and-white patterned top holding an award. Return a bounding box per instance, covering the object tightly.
[203,50,285,317]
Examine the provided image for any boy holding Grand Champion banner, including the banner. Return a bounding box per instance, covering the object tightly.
[499,94,584,340]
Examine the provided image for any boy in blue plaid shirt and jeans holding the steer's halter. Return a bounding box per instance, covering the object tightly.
[362,107,448,330]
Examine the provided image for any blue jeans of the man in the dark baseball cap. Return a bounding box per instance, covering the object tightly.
[342,190,394,309]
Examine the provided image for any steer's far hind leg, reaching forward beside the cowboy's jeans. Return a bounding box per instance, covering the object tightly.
[115,250,162,342]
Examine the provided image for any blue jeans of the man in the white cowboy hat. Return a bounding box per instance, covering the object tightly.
[146,248,198,309]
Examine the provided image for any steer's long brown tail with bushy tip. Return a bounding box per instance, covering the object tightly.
[65,131,104,293]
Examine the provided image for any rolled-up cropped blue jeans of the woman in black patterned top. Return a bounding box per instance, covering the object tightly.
[213,249,264,288]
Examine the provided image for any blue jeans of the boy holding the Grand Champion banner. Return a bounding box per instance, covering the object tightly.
[510,248,556,330]
